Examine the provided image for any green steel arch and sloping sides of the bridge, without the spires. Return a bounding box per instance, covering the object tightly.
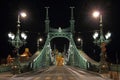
[29,28,97,69]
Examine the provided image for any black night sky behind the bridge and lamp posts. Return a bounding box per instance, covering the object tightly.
[0,0,120,63]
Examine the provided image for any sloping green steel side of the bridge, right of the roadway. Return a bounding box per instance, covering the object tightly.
[68,40,99,71]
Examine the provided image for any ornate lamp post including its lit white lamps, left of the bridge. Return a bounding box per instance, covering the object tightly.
[8,12,27,73]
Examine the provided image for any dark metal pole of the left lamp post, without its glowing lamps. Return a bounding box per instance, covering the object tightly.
[10,14,25,74]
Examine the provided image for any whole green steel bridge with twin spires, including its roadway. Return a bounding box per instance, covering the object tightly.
[0,7,114,80]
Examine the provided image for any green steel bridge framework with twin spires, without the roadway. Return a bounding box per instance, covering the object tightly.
[29,7,99,70]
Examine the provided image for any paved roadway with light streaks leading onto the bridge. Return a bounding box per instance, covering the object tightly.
[0,66,111,80]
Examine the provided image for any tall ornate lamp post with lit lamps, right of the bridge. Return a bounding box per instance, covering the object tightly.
[93,11,111,73]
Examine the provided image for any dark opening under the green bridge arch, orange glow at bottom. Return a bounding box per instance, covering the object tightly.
[50,37,70,66]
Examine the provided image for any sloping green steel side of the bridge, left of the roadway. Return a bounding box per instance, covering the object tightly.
[29,44,53,70]
